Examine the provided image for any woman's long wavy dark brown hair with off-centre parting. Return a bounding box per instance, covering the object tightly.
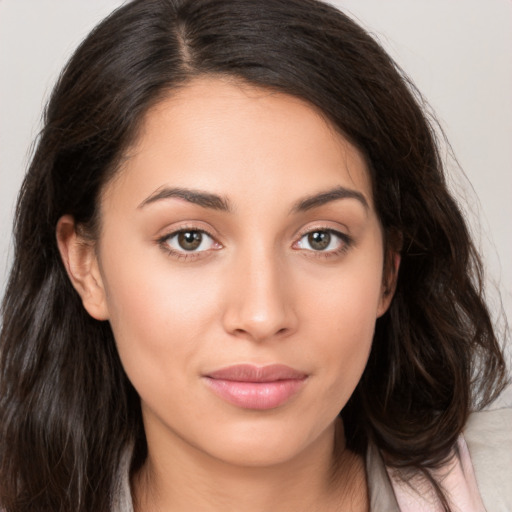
[0,0,506,512]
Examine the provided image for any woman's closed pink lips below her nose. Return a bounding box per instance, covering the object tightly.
[205,364,307,410]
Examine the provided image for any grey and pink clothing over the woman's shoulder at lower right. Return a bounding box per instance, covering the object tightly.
[367,409,512,512]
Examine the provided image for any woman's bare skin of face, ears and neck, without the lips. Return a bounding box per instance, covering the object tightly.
[57,78,393,512]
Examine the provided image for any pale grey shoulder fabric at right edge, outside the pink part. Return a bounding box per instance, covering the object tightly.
[463,408,512,512]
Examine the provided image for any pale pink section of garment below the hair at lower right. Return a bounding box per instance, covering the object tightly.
[387,435,485,512]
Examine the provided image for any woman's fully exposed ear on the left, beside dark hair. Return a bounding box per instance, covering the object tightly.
[56,215,109,320]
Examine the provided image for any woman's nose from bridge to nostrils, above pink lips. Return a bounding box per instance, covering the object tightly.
[223,248,298,342]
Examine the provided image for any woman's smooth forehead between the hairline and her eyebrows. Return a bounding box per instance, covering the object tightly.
[107,78,372,210]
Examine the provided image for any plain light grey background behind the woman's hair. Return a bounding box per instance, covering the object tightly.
[0,0,512,400]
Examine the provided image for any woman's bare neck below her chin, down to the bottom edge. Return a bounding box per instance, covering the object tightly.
[132,422,367,512]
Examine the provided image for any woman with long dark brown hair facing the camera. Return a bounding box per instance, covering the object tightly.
[0,0,510,512]
